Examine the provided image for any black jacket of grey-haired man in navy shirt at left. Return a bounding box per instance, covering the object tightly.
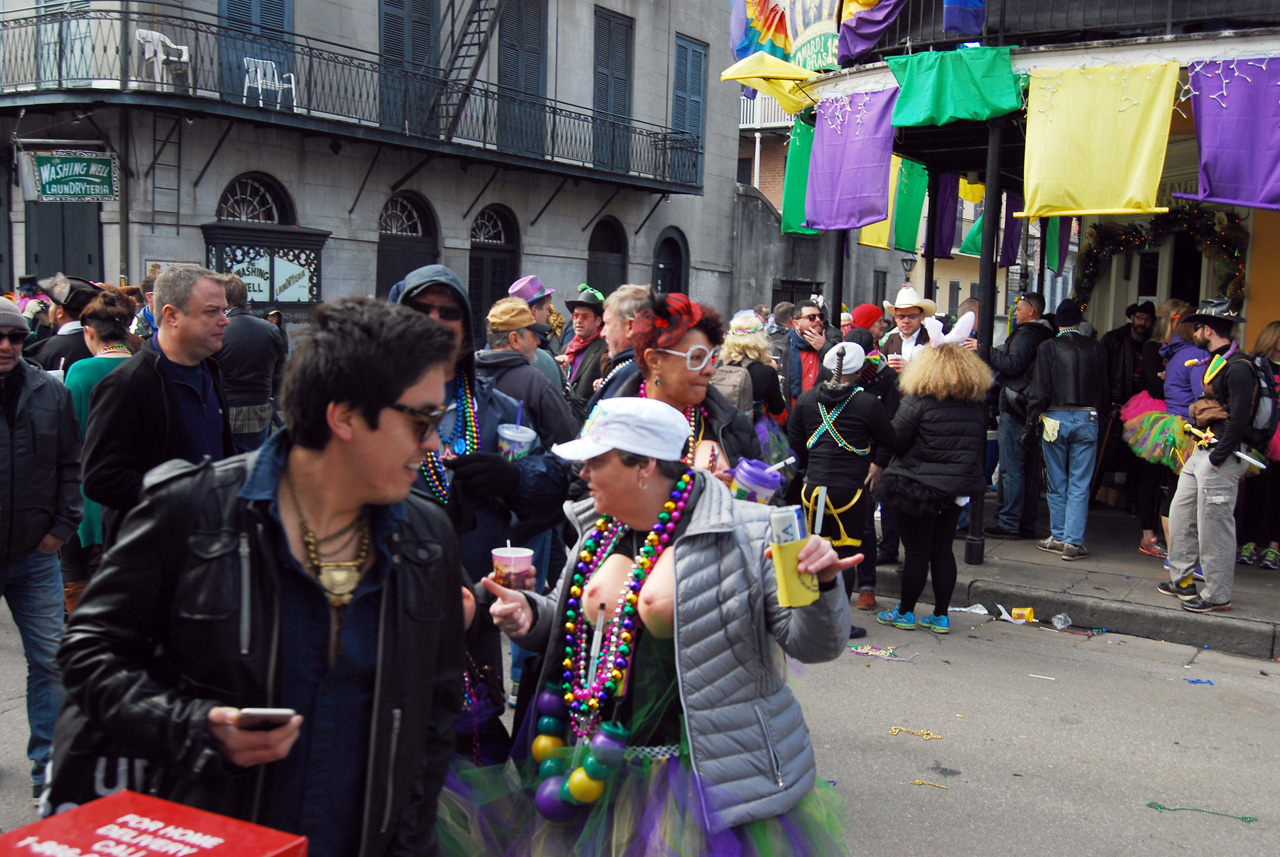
[83,336,233,546]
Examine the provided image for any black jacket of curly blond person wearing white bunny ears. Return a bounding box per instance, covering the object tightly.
[884,395,987,496]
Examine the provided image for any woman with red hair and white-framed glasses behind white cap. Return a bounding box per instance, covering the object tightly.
[604,294,760,472]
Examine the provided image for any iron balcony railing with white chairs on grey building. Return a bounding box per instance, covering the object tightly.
[0,5,703,191]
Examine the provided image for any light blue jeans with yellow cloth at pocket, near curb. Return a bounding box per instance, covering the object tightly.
[1041,411,1098,546]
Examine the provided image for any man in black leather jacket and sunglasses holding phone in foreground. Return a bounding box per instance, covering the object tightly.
[53,298,465,857]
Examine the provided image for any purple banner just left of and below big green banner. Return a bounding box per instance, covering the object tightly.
[804,87,897,230]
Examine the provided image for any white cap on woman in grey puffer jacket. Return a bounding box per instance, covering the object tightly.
[552,397,692,462]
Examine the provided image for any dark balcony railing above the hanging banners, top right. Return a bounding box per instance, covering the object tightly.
[859,0,1280,63]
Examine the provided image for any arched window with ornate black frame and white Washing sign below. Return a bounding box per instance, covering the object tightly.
[201,173,330,306]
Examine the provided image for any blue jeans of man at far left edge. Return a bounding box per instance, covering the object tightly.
[0,550,63,784]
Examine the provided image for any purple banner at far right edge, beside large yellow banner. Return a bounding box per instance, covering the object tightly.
[1175,56,1280,210]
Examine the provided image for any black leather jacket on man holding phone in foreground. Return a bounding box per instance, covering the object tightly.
[54,452,465,857]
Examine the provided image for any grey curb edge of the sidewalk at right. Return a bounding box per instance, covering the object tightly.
[854,569,1277,660]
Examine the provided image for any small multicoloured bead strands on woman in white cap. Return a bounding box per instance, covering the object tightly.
[562,471,694,741]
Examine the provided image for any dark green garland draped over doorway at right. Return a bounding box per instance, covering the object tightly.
[1071,202,1249,307]
